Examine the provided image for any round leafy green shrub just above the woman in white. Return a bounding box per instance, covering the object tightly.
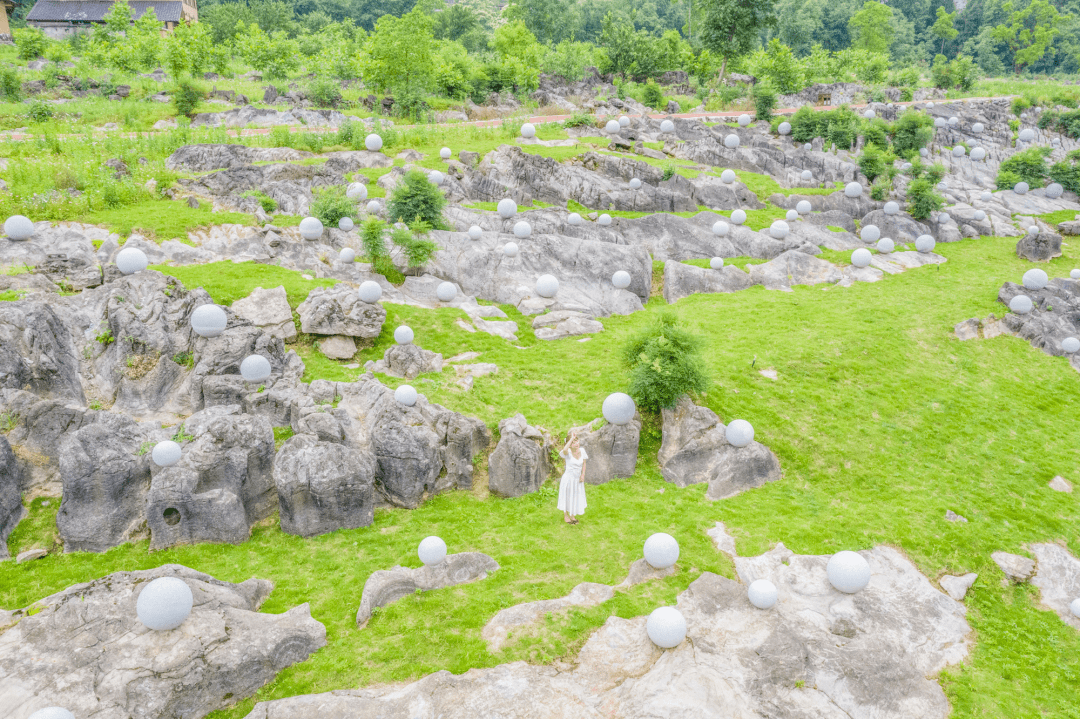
[622,313,708,412]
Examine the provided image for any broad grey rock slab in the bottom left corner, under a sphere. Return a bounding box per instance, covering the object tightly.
[0,565,326,719]
